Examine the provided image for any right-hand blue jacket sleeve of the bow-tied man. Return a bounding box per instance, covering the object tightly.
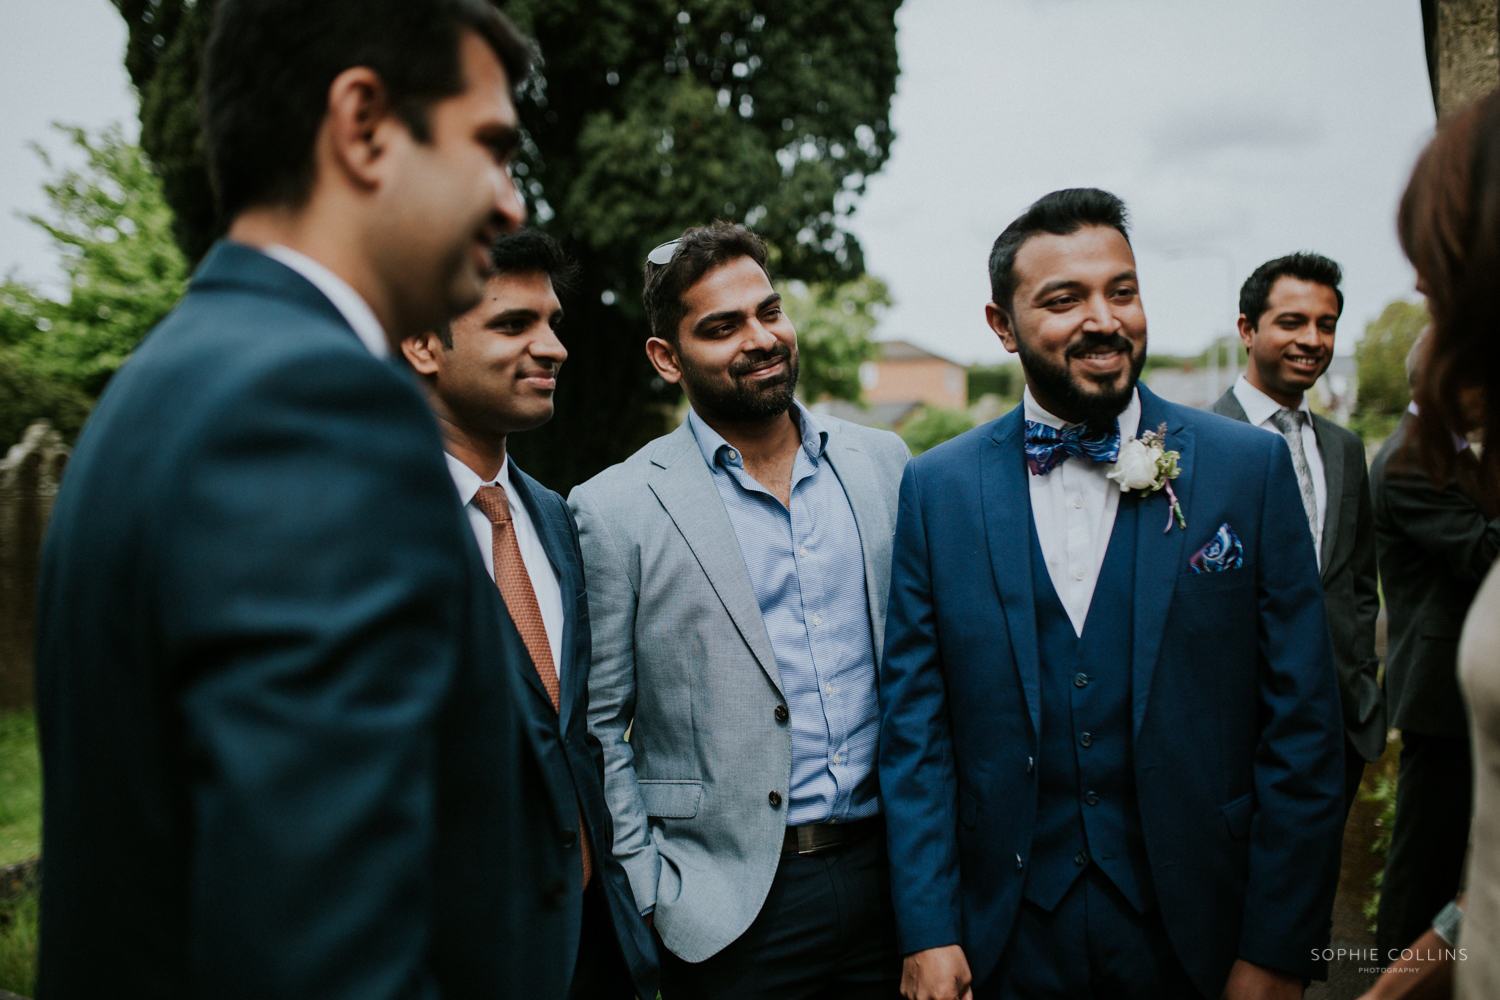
[1239,438,1344,979]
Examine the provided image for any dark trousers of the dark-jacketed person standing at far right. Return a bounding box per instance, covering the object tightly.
[1376,733,1475,961]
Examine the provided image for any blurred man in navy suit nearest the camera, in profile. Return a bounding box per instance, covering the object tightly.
[36,0,579,1000]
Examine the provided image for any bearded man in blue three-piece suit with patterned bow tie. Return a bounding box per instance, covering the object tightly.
[881,189,1344,1000]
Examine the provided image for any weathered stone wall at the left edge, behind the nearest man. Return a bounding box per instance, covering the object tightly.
[0,420,69,711]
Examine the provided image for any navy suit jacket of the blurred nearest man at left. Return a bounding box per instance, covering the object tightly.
[36,243,578,1000]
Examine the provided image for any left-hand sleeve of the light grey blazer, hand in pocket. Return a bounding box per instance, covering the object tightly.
[569,487,662,913]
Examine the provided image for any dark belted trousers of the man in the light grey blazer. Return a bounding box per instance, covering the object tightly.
[657,831,902,1000]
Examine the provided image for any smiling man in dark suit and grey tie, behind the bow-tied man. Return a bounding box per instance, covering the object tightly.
[1214,253,1386,816]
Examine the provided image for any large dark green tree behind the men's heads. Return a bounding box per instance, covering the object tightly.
[114,0,900,490]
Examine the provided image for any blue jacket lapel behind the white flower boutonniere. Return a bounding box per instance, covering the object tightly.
[1122,385,1194,738]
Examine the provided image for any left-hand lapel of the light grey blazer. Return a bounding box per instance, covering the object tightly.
[647,421,786,697]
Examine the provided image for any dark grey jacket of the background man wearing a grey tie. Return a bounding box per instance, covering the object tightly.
[1214,390,1386,760]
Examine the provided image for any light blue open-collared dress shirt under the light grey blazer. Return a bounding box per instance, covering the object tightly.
[687,403,881,826]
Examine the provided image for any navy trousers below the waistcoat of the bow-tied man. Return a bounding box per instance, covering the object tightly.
[974,865,1200,1000]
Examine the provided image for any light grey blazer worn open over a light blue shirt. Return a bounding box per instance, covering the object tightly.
[569,414,911,963]
